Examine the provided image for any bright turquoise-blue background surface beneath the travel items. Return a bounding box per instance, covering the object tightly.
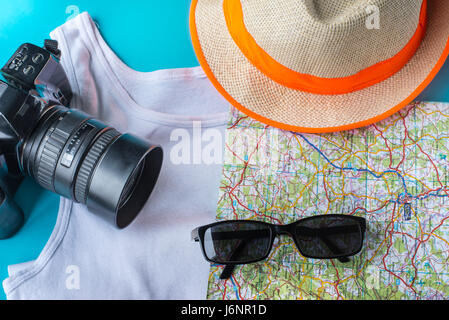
[0,0,449,299]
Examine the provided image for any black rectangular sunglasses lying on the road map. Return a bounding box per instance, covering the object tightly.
[192,214,366,279]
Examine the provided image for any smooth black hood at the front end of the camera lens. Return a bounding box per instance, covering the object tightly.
[86,134,163,229]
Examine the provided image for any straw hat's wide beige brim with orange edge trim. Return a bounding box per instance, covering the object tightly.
[190,0,449,133]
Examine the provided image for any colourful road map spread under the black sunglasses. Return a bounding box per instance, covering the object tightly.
[208,103,449,299]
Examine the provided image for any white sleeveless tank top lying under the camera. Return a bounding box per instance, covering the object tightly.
[3,13,229,299]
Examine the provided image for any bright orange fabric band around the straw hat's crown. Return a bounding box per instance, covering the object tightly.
[223,0,427,95]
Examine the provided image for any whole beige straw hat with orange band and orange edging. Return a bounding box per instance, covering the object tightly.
[190,0,449,133]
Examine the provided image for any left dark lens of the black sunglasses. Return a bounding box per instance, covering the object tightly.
[204,221,271,264]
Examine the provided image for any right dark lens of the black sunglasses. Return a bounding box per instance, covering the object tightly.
[295,216,363,259]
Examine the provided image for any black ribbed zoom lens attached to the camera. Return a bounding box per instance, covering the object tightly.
[19,106,163,228]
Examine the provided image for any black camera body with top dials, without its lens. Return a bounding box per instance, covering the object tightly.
[0,40,72,148]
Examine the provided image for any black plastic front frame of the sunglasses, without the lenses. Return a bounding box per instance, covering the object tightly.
[191,214,366,265]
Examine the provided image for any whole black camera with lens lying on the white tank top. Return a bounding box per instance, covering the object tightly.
[0,40,163,238]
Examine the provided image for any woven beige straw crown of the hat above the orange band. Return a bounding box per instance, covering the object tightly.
[237,0,423,78]
